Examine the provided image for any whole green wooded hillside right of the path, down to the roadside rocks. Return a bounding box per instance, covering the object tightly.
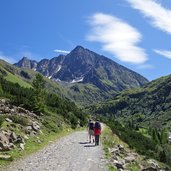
[89,75,171,165]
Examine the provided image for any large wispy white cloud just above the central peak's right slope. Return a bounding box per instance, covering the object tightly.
[86,13,147,64]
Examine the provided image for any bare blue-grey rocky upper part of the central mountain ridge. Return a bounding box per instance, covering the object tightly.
[14,46,148,91]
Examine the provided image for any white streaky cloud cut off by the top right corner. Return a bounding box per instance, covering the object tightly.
[126,0,171,34]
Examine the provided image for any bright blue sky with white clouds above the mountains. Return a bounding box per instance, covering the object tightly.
[0,0,171,80]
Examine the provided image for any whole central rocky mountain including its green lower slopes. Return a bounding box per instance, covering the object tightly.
[15,46,148,104]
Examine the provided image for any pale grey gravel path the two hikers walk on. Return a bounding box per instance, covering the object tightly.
[4,131,108,171]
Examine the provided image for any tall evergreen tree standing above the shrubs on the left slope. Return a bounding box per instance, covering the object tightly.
[32,73,45,114]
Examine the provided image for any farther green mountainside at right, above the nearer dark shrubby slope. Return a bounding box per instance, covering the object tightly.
[91,75,171,128]
